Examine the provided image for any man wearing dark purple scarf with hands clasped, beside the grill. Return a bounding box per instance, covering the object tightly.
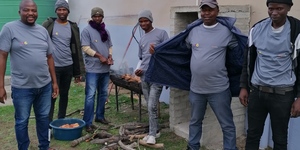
[81,7,113,132]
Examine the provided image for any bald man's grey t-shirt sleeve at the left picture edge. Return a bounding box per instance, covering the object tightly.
[0,25,12,52]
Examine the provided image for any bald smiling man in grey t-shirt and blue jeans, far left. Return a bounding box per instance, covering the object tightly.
[0,0,59,150]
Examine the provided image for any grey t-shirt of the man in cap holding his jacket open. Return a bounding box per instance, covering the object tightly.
[186,23,237,94]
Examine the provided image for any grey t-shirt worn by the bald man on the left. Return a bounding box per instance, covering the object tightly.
[0,20,54,88]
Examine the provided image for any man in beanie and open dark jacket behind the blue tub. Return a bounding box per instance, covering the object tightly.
[43,0,84,128]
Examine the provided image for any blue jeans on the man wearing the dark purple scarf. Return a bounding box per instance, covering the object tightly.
[83,72,109,126]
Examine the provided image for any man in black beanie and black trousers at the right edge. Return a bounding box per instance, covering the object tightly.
[239,0,300,150]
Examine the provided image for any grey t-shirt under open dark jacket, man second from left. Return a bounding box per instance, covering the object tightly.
[52,21,73,67]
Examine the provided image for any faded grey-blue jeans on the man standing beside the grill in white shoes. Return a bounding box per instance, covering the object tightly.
[142,81,162,137]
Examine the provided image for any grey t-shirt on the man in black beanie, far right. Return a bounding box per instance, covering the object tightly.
[249,18,296,87]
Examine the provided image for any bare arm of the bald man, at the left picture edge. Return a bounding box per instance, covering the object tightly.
[0,50,8,103]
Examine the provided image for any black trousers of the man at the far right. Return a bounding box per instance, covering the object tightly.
[246,88,294,150]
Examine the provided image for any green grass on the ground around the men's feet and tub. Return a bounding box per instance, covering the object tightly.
[0,84,187,150]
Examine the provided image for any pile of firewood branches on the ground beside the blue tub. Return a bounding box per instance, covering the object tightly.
[71,123,164,150]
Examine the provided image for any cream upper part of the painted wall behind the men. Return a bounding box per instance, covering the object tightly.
[69,0,300,27]
